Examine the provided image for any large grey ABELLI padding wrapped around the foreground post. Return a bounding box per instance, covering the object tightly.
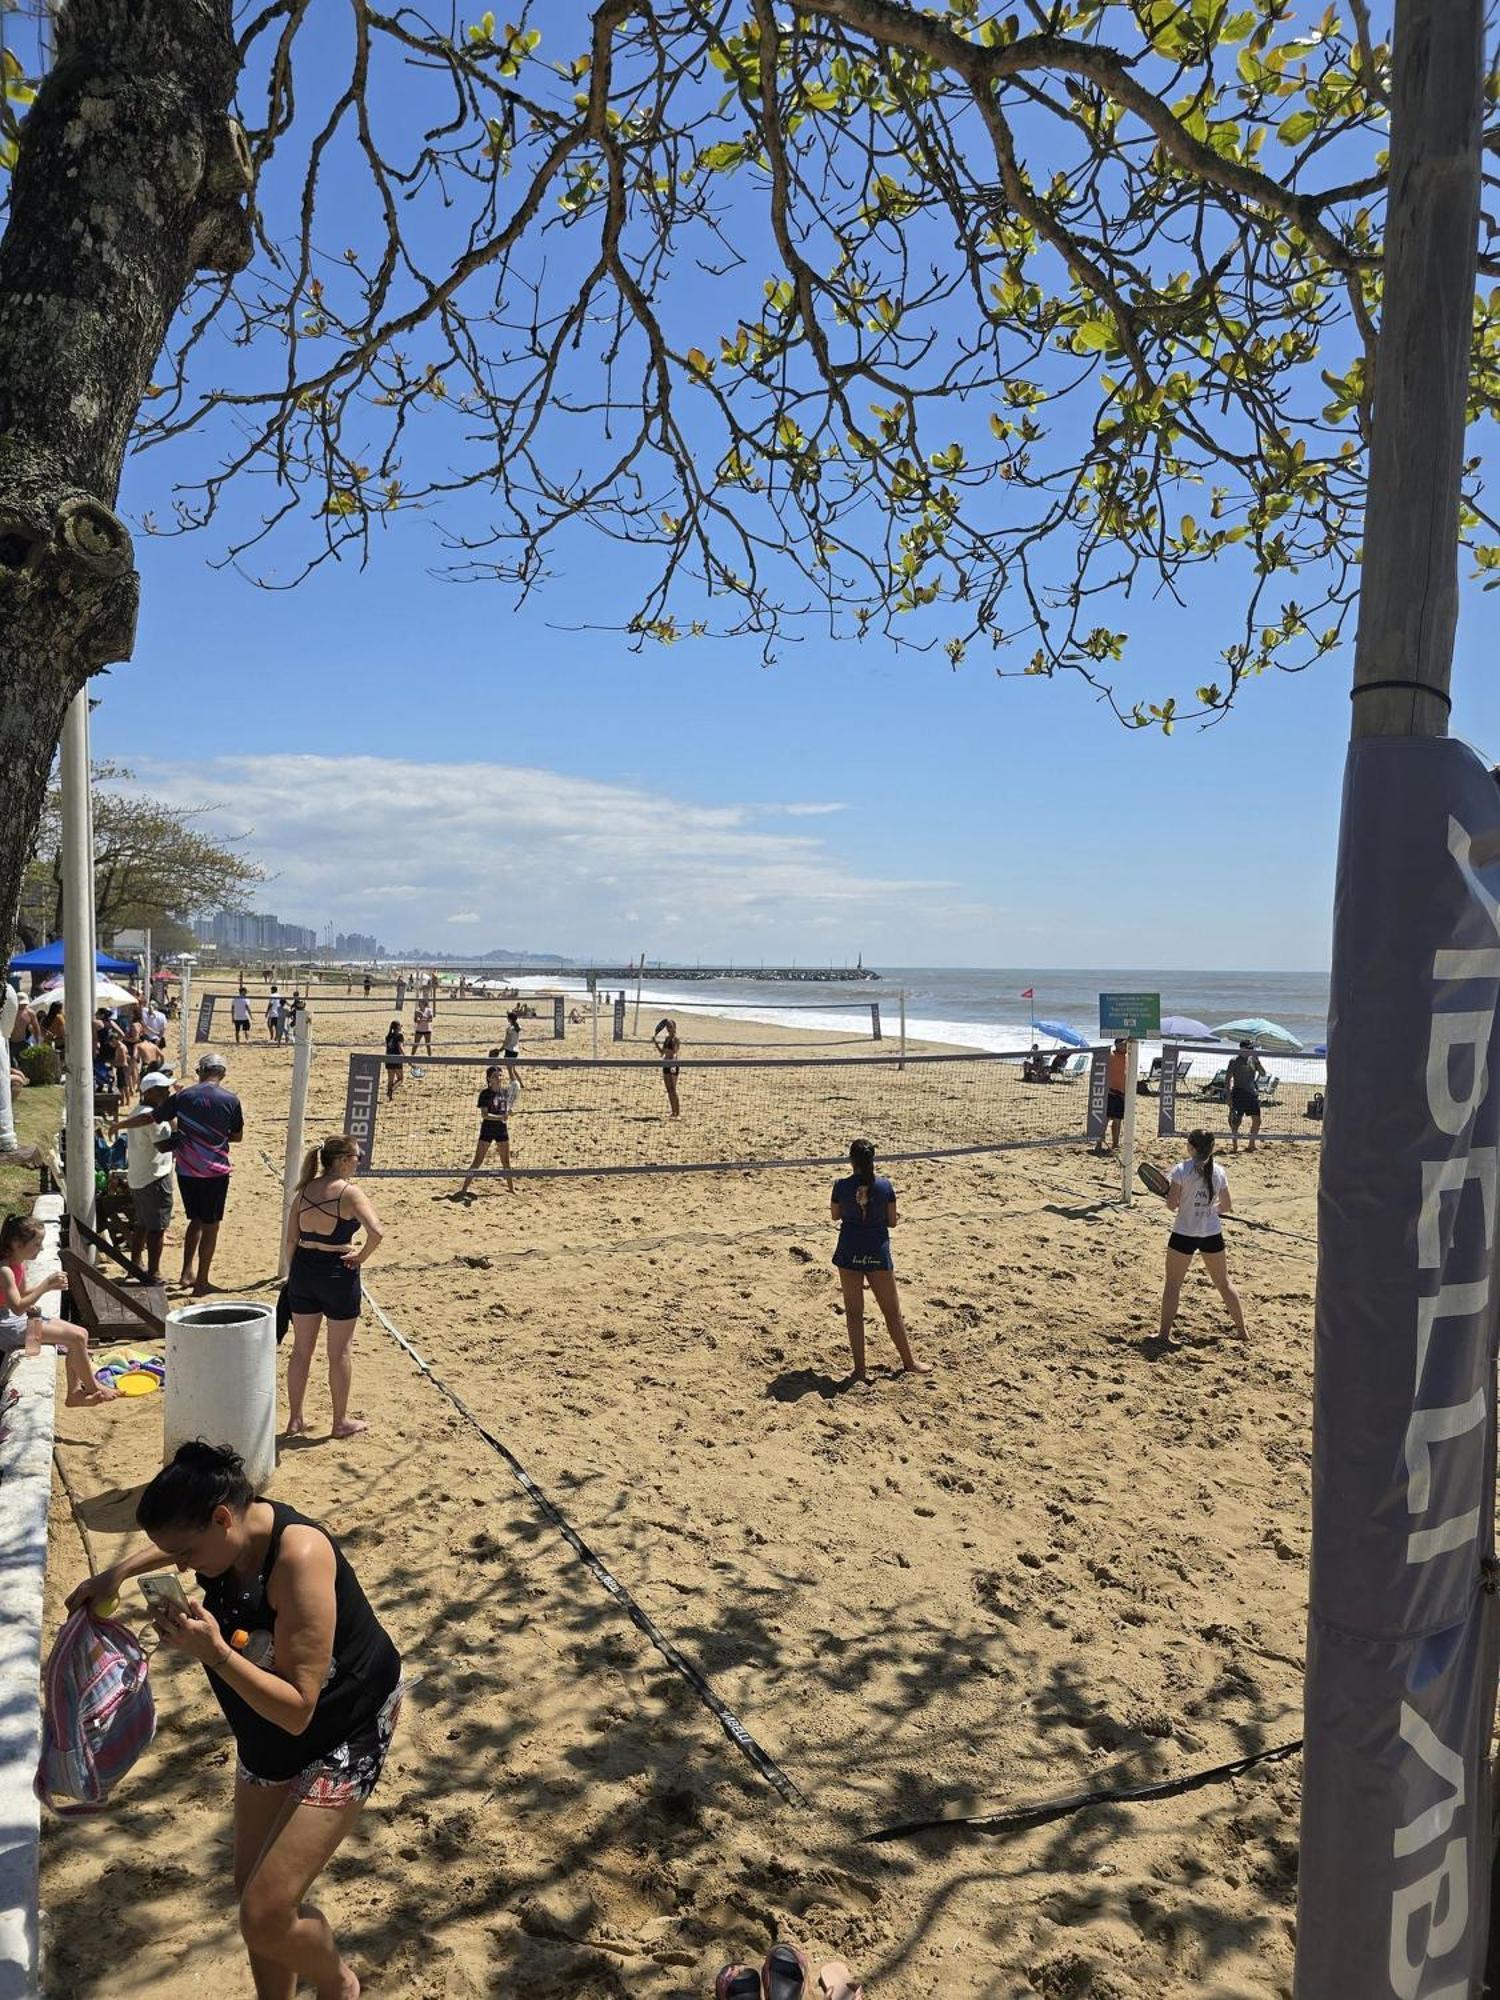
[1296,736,1500,2000]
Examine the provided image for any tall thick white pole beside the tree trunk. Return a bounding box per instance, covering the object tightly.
[62,688,94,1262]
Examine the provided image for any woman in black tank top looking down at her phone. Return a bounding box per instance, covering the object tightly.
[68,1440,402,2000]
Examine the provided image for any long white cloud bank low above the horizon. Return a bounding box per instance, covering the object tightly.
[123,754,994,962]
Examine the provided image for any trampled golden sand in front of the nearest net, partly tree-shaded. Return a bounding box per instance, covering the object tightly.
[42,1000,1316,2000]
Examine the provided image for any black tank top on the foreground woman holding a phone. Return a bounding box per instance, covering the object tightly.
[198,1500,402,1784]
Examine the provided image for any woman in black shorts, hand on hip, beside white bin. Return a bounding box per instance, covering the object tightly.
[286,1132,384,1438]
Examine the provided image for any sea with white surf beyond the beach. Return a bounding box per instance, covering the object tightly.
[518,966,1328,1052]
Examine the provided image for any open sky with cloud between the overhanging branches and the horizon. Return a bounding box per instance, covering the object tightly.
[61,0,1500,968]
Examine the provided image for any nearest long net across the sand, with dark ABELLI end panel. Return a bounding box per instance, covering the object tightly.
[346,1052,1088,1178]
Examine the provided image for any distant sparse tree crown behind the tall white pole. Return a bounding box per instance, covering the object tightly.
[20,764,266,948]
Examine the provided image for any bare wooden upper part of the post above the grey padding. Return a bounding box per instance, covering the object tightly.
[1352,0,1484,736]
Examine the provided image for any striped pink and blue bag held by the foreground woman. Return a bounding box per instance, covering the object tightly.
[34,1608,156,1818]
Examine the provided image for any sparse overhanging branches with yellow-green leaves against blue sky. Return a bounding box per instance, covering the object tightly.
[0,0,1500,744]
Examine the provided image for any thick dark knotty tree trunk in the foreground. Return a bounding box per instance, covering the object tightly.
[0,0,252,956]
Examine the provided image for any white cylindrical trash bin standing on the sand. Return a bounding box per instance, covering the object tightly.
[162,1298,276,1492]
